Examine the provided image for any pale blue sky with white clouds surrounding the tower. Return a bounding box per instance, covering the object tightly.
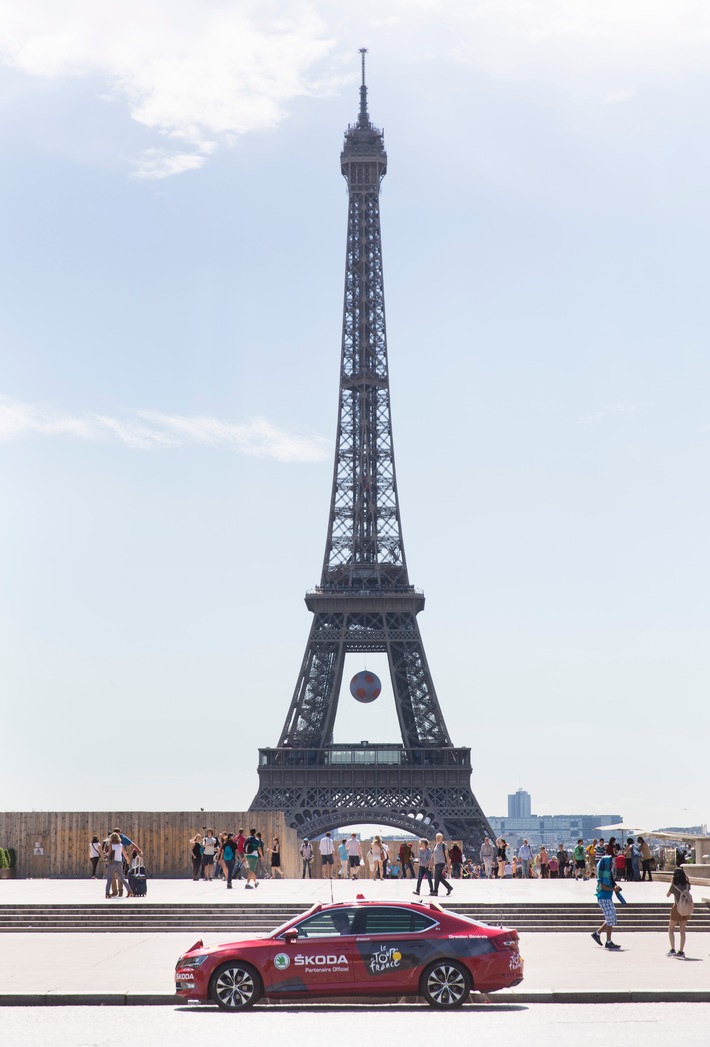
[0,0,710,825]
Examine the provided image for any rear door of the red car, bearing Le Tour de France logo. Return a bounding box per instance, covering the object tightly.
[353,905,439,993]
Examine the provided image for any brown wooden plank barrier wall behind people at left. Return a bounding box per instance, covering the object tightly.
[0,810,301,878]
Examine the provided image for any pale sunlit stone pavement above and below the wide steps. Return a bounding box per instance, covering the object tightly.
[0,879,710,1004]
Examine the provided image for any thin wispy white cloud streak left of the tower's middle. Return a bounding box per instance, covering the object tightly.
[0,396,329,462]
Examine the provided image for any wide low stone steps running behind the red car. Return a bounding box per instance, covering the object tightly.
[0,898,710,937]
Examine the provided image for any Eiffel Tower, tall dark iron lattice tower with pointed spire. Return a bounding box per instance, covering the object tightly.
[250,50,492,853]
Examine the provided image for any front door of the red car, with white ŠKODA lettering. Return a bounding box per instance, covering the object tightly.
[264,907,355,996]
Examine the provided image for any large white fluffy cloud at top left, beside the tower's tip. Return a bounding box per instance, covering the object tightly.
[0,0,332,178]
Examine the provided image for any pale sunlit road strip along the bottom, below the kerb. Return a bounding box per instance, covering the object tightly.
[11,1003,710,1047]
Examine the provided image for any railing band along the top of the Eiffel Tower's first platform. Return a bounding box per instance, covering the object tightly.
[259,744,471,767]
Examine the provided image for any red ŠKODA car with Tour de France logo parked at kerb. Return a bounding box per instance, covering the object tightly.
[175,898,523,1010]
